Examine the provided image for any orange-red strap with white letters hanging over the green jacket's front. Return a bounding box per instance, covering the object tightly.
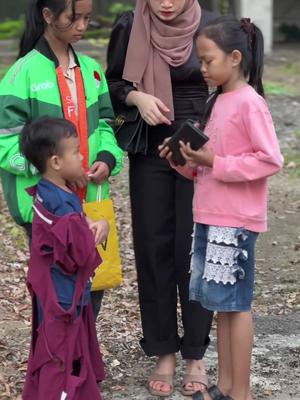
[56,66,89,201]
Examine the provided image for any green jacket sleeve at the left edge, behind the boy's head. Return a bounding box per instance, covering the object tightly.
[0,63,37,176]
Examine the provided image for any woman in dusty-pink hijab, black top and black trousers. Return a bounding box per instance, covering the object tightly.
[106,0,215,397]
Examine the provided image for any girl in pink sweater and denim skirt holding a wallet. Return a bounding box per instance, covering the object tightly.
[161,17,283,400]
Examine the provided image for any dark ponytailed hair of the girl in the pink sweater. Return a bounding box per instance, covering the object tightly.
[199,16,264,126]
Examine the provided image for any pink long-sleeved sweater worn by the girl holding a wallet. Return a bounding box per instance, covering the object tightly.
[176,85,283,232]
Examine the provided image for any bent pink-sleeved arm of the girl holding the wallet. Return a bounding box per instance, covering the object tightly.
[212,100,283,182]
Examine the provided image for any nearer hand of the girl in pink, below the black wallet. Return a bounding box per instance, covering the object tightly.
[179,141,215,168]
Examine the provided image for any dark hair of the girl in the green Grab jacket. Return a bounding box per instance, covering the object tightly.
[18,0,77,58]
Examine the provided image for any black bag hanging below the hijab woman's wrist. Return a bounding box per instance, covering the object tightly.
[115,107,148,154]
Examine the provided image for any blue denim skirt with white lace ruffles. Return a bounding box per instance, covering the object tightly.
[190,223,258,312]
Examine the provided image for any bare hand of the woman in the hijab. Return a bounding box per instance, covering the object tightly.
[126,90,171,126]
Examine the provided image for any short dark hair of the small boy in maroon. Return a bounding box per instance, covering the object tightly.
[20,117,78,174]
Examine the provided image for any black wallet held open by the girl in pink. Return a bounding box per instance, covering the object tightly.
[166,119,208,165]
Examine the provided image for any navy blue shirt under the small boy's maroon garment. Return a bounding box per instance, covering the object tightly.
[36,178,91,309]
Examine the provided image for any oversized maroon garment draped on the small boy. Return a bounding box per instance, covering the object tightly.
[23,191,104,400]
